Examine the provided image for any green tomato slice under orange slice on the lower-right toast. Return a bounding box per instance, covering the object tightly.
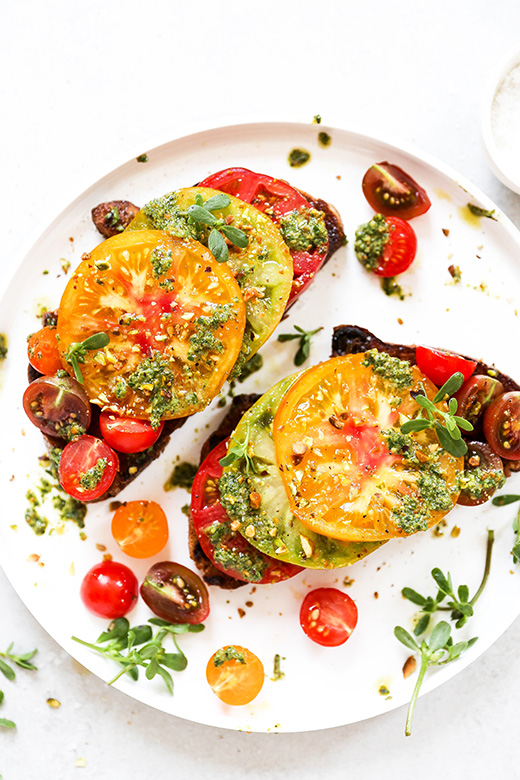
[219,371,384,569]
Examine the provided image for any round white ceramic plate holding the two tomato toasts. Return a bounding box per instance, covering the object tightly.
[0,123,520,732]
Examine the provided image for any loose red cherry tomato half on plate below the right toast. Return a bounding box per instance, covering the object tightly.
[300,588,358,647]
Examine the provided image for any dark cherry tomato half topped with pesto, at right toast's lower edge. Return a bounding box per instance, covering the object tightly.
[457,441,505,506]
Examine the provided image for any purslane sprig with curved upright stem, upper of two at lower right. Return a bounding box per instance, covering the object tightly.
[401,529,495,636]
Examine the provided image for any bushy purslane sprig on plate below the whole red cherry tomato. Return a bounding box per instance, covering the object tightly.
[72,618,204,695]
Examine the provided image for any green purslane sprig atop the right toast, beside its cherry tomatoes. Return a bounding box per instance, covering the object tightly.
[401,371,473,458]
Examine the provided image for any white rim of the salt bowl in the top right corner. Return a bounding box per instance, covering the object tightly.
[480,49,520,194]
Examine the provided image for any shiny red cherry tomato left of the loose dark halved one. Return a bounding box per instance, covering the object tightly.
[80,561,139,620]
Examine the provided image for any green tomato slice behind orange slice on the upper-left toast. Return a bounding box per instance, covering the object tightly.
[127,187,293,376]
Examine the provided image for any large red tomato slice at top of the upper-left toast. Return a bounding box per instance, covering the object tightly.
[200,168,329,306]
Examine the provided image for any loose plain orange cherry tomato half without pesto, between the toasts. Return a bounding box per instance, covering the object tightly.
[112,501,168,558]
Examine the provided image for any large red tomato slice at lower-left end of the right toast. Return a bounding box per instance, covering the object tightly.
[191,439,302,585]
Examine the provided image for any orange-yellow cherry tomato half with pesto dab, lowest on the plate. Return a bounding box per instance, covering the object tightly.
[206,645,265,707]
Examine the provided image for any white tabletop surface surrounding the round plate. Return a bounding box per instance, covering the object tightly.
[0,0,520,780]
